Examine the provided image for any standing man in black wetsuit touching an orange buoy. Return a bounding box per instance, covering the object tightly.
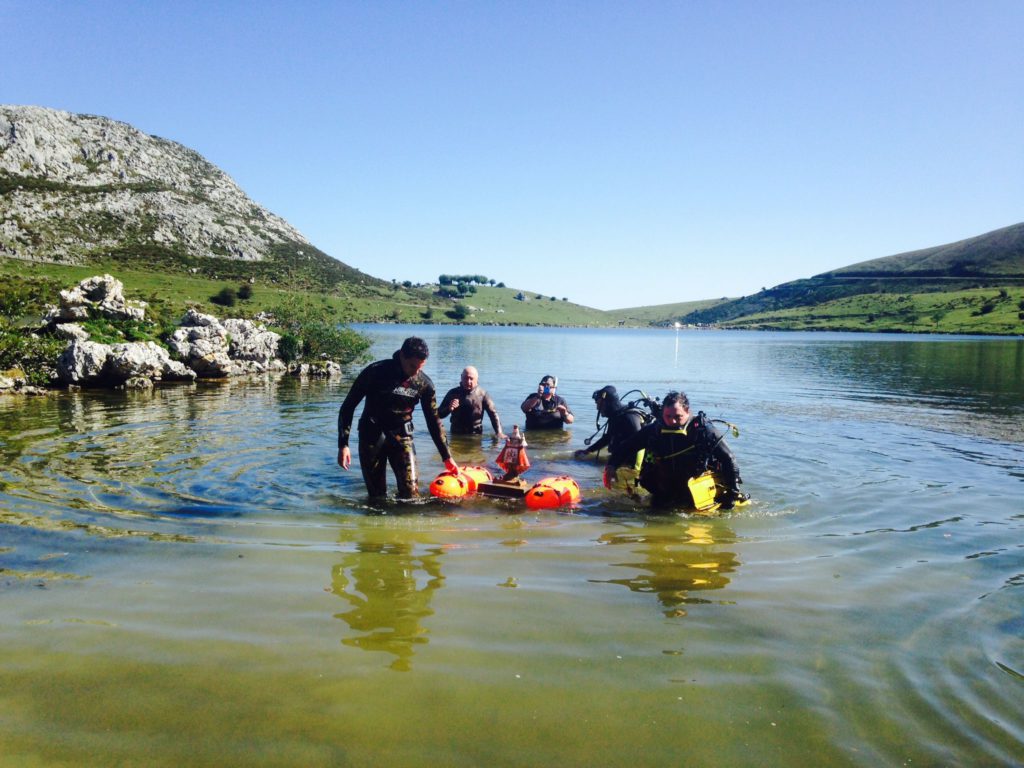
[338,336,459,499]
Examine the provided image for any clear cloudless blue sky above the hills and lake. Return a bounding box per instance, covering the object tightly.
[0,0,1024,309]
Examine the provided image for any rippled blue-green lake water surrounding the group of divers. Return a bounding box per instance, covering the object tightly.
[0,326,1024,768]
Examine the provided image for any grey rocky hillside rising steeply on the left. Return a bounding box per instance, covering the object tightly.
[0,105,379,290]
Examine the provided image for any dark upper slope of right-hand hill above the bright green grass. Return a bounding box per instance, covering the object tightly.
[676,223,1024,325]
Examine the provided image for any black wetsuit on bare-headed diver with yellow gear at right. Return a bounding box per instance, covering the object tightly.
[608,414,742,506]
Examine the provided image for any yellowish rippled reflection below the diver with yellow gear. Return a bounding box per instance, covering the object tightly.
[591,520,739,616]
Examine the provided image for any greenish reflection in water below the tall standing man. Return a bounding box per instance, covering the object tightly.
[331,526,444,672]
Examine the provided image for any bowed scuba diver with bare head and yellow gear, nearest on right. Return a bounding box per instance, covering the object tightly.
[604,392,750,509]
